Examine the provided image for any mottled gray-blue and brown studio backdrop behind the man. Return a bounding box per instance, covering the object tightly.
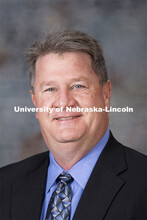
[0,0,147,166]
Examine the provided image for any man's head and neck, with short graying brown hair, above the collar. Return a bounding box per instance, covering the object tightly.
[28,31,111,168]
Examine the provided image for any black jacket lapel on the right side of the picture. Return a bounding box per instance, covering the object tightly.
[73,135,127,220]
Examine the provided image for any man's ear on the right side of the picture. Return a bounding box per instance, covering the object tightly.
[102,80,111,109]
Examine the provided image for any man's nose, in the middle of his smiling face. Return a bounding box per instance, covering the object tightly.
[53,89,77,109]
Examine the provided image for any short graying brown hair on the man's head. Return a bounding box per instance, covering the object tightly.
[27,31,108,89]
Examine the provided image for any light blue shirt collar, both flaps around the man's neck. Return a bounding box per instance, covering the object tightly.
[46,129,110,193]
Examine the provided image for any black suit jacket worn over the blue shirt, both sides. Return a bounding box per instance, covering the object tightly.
[0,135,147,220]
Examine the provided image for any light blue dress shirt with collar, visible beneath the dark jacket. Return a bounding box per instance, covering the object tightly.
[40,129,109,220]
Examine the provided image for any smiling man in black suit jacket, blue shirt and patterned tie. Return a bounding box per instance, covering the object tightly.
[0,31,147,220]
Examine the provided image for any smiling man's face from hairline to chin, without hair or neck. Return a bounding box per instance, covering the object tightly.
[32,52,110,156]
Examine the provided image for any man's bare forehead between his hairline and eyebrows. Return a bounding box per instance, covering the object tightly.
[35,52,98,87]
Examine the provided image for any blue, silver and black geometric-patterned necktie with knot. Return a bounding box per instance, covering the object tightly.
[46,172,73,220]
